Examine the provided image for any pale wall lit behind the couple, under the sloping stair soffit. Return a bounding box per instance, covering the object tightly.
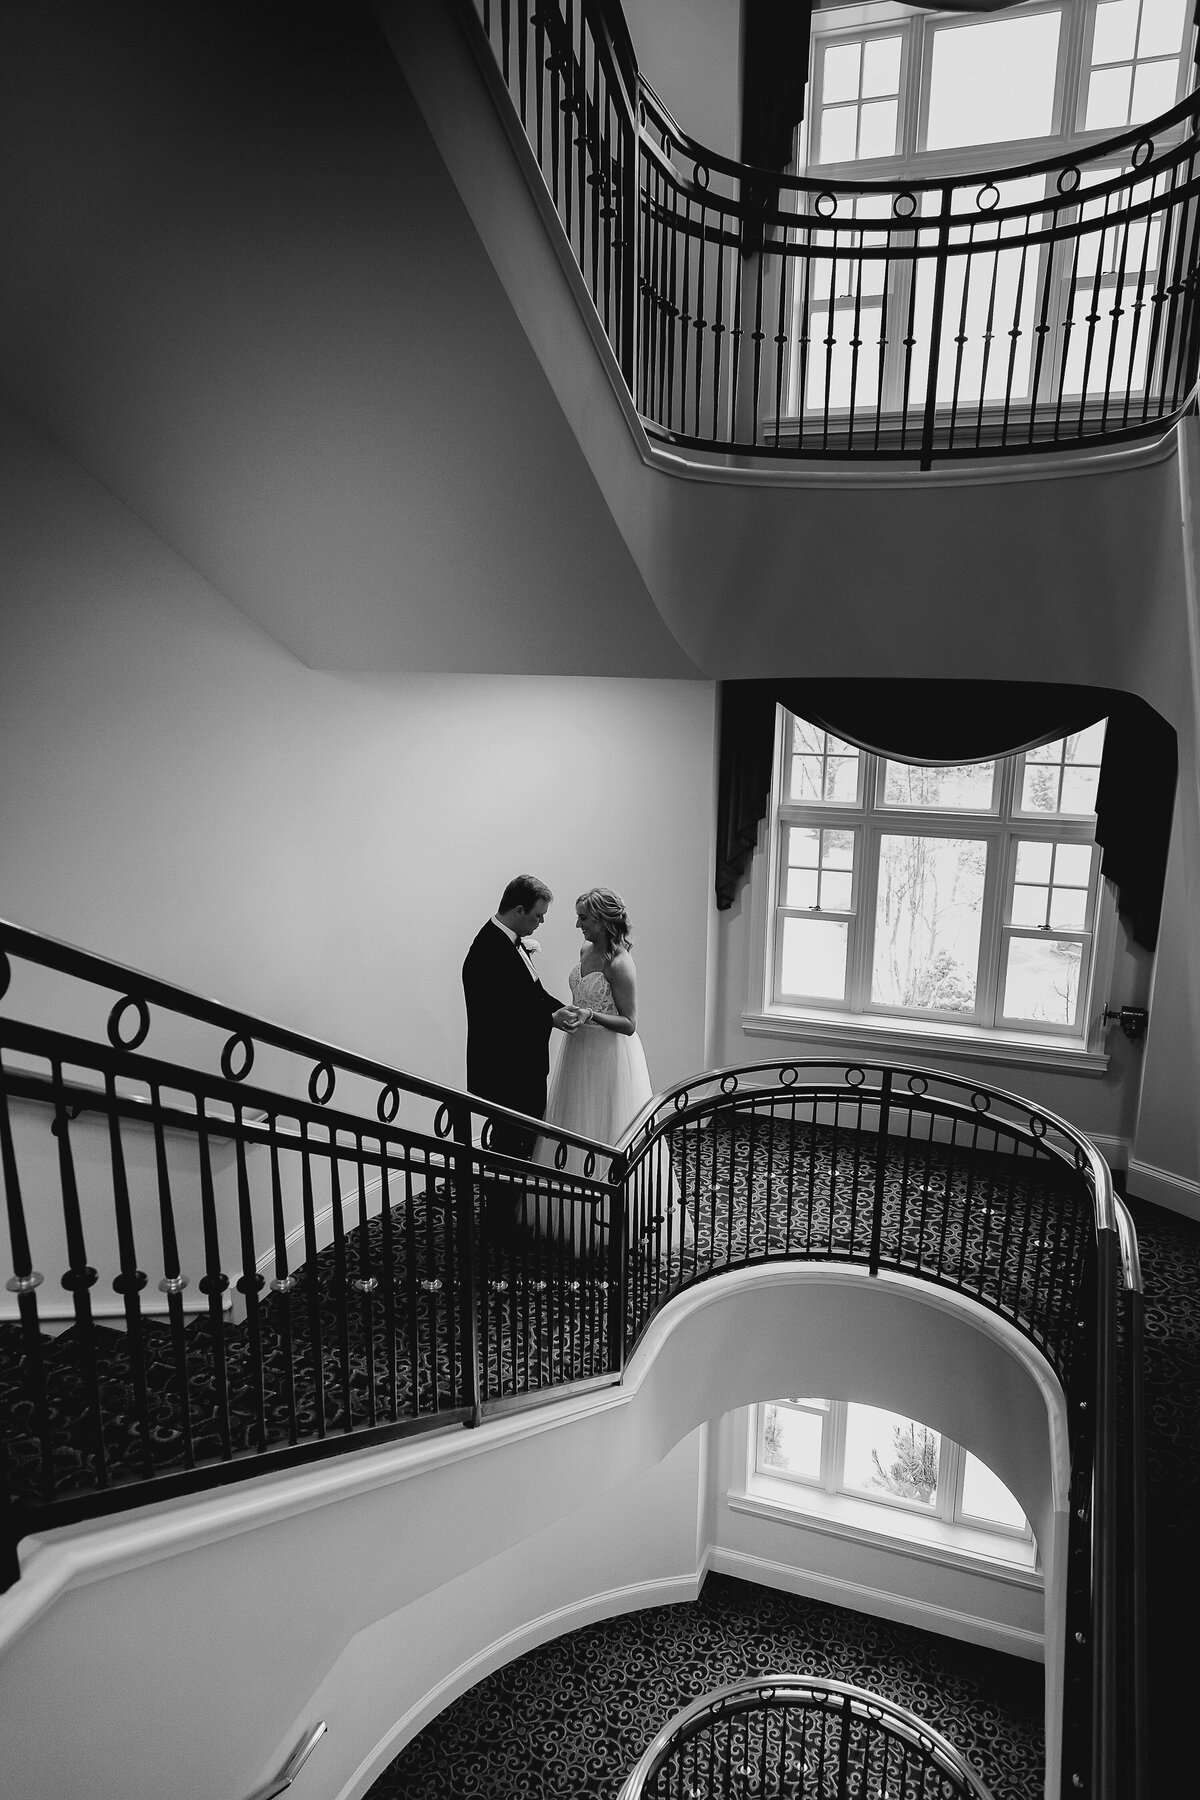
[0,399,712,1084]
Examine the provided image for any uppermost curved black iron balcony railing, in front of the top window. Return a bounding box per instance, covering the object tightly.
[461,0,1200,468]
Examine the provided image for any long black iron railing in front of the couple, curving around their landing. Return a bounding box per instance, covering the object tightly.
[0,922,1142,1800]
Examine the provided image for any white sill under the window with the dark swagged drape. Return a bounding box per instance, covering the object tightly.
[741,1006,1108,1075]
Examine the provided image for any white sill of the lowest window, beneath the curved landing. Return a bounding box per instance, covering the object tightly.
[729,1476,1043,1589]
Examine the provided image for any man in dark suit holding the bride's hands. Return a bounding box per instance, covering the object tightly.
[462,875,576,1157]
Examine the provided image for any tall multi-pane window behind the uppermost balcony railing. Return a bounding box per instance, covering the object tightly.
[786,0,1193,428]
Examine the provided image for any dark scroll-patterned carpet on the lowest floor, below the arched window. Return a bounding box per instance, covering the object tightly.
[371,1575,1045,1800]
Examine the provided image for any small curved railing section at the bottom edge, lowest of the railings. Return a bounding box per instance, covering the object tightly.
[617,1676,988,1800]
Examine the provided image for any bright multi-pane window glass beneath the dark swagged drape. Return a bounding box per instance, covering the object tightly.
[772,709,1105,1037]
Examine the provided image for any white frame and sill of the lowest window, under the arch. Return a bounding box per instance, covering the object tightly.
[727,1400,1042,1586]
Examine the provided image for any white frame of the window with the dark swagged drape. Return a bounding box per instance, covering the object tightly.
[741,707,1117,1073]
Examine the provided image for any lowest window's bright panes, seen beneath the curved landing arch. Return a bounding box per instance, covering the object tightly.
[754,1400,1031,1539]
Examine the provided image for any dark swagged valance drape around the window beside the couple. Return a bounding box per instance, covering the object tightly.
[716,680,1178,950]
